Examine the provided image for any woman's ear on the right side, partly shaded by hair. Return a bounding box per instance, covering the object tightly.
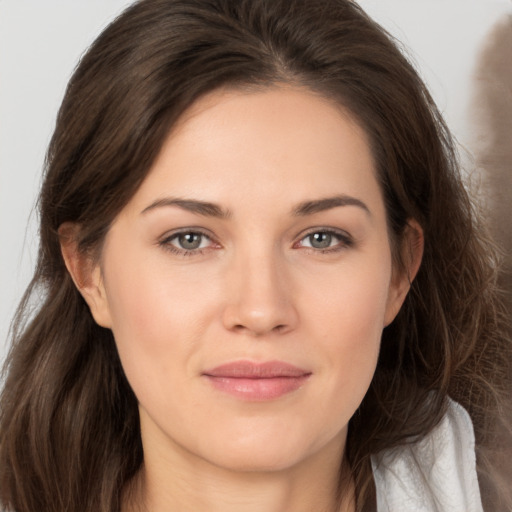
[384,219,425,326]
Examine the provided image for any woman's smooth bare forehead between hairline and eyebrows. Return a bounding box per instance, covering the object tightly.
[121,87,380,218]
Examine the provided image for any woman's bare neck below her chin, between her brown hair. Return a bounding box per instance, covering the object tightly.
[122,432,355,512]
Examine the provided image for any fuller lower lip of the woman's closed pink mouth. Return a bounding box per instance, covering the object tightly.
[206,374,309,402]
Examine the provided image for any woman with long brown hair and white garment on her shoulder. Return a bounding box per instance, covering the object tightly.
[0,0,508,512]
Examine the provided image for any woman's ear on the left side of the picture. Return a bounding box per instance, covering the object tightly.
[59,222,111,328]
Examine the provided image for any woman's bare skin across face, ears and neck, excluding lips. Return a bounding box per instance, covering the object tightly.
[63,88,421,512]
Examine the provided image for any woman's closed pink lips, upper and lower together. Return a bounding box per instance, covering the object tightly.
[202,361,311,402]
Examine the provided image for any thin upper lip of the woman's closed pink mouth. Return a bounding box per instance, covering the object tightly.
[203,361,311,379]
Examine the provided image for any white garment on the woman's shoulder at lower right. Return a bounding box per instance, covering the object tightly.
[372,400,483,512]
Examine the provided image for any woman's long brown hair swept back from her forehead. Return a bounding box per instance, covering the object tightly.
[0,0,509,512]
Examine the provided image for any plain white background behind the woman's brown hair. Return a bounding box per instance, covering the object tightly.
[0,0,512,361]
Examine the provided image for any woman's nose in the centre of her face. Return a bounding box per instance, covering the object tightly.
[222,250,298,336]
